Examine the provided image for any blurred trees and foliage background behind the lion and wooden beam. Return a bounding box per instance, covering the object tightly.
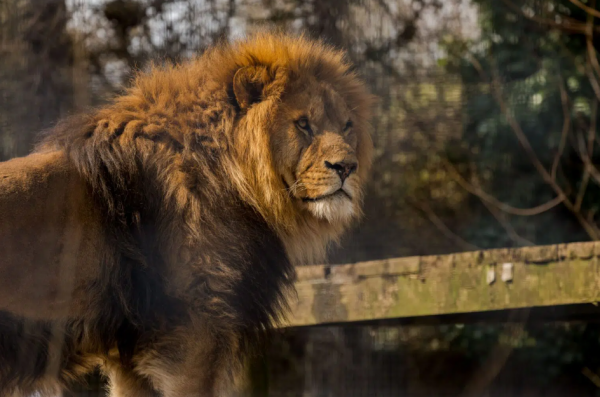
[5,0,600,396]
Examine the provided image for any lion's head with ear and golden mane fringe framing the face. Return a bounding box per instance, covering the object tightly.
[229,51,372,240]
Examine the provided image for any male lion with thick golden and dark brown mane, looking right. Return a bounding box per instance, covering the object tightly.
[0,33,372,397]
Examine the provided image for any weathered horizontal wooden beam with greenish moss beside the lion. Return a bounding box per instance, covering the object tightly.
[284,242,600,326]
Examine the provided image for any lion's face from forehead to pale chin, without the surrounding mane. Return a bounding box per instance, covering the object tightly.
[271,79,367,223]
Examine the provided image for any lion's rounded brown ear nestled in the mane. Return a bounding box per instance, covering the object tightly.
[233,66,271,110]
